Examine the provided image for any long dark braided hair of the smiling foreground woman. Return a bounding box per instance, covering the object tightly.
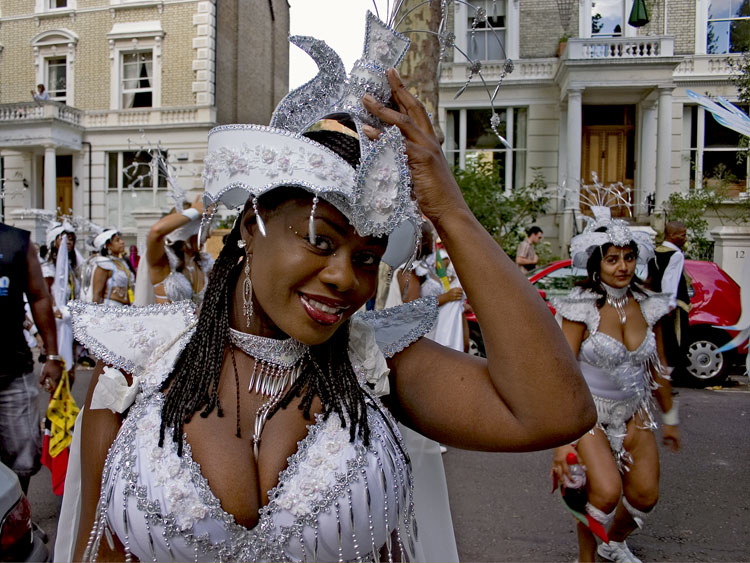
[159,126,378,455]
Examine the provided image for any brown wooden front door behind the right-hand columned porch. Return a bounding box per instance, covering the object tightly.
[581,125,633,217]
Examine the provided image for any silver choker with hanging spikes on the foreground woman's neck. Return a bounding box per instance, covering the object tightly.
[229,328,309,461]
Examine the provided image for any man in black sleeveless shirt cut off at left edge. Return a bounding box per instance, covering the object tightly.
[0,223,62,493]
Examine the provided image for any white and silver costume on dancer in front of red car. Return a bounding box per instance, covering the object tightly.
[553,287,669,469]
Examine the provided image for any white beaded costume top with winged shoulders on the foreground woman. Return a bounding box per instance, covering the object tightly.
[66,299,437,561]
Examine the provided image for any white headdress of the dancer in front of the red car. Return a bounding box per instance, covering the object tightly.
[570,177,654,268]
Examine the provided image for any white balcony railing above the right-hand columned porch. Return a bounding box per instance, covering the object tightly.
[563,35,674,60]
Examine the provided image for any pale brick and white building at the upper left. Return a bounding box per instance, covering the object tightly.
[0,0,289,247]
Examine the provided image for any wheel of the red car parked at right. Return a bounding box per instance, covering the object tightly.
[685,328,731,387]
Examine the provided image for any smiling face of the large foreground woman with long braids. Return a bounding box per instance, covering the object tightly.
[242,197,386,345]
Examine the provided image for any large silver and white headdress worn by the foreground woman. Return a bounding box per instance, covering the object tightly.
[201,13,421,266]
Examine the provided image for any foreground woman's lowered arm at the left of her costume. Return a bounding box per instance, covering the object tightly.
[73,362,131,561]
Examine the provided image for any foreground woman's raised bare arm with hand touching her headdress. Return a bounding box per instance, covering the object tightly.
[364,70,596,451]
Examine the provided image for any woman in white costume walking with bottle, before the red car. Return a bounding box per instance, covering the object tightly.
[552,206,679,563]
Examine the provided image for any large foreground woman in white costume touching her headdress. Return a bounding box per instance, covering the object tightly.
[61,14,595,561]
